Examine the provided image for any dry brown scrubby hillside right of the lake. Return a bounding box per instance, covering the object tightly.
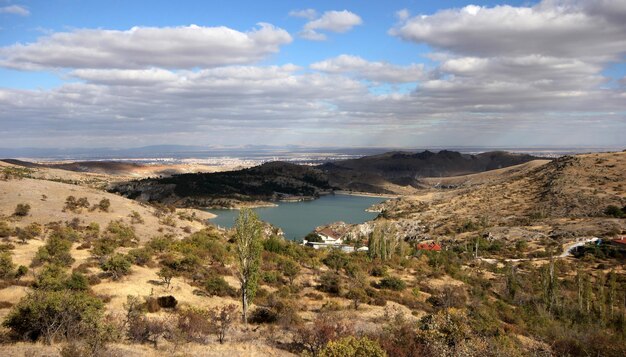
[380,152,626,245]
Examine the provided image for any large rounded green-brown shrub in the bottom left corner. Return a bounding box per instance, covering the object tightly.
[3,290,104,343]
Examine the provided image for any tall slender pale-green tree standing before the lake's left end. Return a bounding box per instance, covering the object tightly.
[235,209,262,325]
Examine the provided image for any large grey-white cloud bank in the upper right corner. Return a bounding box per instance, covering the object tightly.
[390,0,626,59]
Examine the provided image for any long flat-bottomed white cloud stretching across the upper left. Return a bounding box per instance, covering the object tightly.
[0,23,292,69]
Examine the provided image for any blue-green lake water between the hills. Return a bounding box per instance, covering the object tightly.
[207,195,385,240]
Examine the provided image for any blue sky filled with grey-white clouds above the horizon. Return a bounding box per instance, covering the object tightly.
[0,0,626,148]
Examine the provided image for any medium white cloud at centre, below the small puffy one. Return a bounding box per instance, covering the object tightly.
[311,55,424,83]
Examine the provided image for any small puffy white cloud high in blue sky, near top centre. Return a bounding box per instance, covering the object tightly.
[299,10,363,41]
